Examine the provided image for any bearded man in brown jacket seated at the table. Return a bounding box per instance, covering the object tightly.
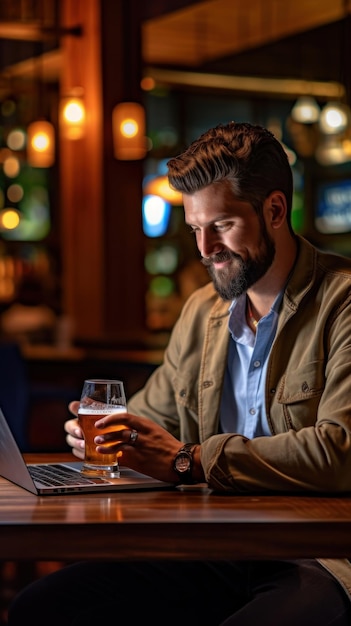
[9,122,351,626]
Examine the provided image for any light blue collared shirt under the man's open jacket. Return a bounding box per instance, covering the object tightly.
[220,291,283,439]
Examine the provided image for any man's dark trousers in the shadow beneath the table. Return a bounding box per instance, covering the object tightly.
[8,559,351,626]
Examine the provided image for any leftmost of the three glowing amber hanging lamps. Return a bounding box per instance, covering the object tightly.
[27,120,55,168]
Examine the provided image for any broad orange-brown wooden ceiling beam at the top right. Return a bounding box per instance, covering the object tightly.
[142,0,351,68]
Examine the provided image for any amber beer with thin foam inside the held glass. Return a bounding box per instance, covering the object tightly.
[78,406,126,475]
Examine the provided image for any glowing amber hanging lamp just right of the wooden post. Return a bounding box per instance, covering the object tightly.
[112,102,146,161]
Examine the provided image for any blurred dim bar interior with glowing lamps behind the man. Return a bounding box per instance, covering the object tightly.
[0,0,351,449]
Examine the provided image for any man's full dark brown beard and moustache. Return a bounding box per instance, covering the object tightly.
[201,228,275,301]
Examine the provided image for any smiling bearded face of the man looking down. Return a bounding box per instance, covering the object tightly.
[183,182,275,300]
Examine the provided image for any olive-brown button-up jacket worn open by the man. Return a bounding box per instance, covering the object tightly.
[128,238,351,593]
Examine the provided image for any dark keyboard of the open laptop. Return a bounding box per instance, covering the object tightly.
[28,463,107,487]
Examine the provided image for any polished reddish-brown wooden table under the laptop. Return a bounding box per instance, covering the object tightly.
[0,455,351,561]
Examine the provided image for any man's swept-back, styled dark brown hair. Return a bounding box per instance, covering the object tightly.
[167,122,293,228]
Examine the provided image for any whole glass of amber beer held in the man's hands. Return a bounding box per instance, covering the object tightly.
[78,379,127,478]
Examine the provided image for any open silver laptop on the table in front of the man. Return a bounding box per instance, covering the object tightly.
[0,408,174,496]
